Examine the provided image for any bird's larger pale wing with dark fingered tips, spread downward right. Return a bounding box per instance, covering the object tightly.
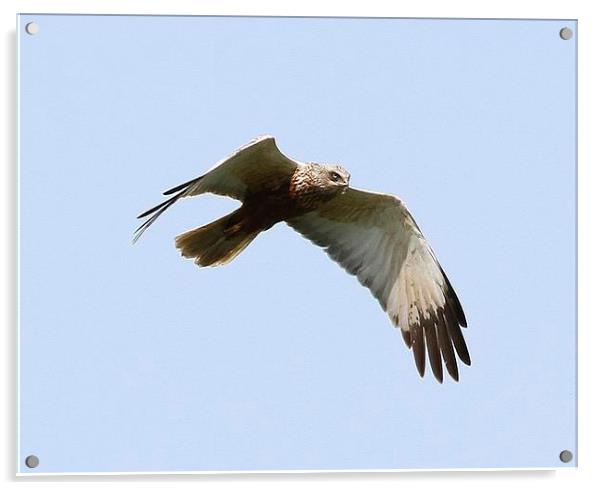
[288,188,470,382]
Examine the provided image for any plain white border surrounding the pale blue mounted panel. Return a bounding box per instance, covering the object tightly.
[0,0,602,490]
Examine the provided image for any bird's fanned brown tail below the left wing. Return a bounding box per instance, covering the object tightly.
[176,211,259,267]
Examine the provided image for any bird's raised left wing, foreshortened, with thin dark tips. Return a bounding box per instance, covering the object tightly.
[134,135,297,242]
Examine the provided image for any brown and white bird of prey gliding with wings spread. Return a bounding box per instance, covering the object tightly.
[134,135,470,383]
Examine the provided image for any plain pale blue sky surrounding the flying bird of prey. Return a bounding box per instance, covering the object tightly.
[17,15,576,472]
